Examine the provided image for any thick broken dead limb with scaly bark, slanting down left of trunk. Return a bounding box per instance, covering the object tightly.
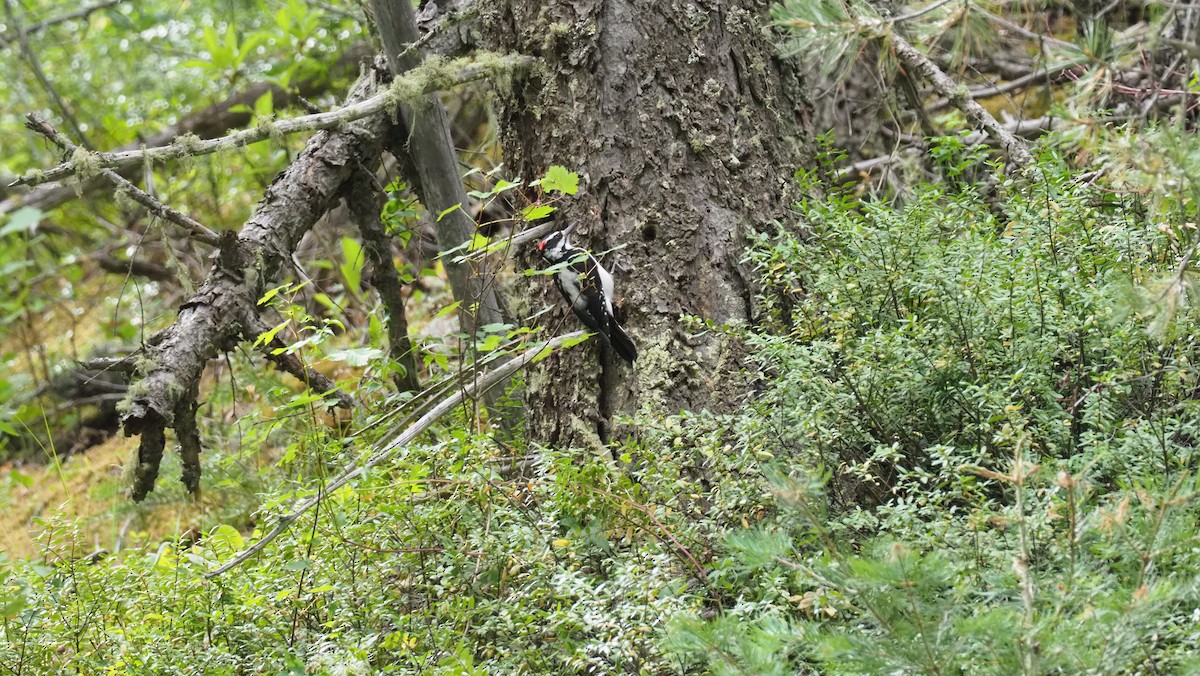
[121,64,390,499]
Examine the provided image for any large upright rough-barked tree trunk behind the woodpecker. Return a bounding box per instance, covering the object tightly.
[486,0,811,447]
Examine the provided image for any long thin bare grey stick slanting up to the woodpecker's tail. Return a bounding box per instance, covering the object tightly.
[204,331,583,579]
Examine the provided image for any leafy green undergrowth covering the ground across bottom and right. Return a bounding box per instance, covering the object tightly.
[7,139,1200,674]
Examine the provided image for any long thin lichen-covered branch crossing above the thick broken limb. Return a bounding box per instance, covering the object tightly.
[11,54,533,185]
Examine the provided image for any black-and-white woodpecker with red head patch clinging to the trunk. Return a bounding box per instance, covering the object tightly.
[538,228,637,364]
